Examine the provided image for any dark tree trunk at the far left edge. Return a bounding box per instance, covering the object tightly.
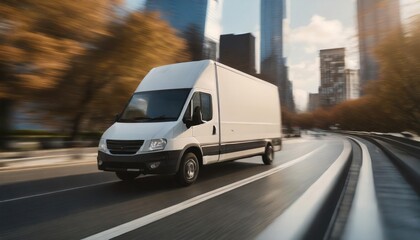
[0,99,14,148]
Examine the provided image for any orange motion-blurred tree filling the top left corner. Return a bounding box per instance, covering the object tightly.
[0,0,119,139]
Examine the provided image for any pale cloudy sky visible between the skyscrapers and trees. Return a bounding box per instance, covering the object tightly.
[126,0,420,111]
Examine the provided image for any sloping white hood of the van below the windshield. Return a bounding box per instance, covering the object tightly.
[102,122,176,140]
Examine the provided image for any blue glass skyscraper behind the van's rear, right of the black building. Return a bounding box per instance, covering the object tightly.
[260,0,294,111]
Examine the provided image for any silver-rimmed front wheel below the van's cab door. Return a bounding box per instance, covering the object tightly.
[176,153,200,187]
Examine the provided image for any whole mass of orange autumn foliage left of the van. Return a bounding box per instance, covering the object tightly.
[0,0,187,141]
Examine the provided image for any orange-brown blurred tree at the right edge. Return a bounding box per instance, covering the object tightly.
[368,16,420,133]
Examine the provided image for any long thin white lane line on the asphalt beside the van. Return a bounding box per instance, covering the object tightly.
[84,144,327,240]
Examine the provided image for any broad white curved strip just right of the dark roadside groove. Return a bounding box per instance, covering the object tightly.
[343,137,384,239]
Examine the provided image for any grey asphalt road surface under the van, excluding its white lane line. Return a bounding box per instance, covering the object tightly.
[0,137,343,239]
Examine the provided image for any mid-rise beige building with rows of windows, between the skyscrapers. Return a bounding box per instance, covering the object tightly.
[319,48,346,108]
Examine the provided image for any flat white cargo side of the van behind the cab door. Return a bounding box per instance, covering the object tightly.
[216,64,281,160]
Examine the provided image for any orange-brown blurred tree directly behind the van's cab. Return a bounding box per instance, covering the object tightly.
[44,12,187,138]
